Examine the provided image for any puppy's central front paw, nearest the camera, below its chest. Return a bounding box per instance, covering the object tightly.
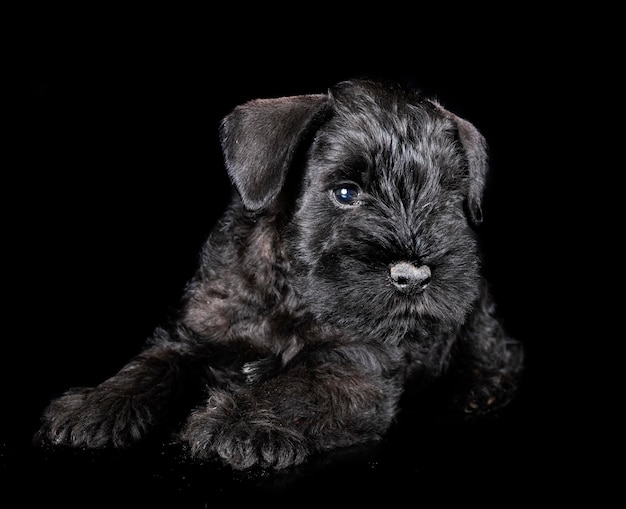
[181,392,308,470]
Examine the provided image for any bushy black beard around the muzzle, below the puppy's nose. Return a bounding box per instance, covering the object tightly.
[299,252,479,345]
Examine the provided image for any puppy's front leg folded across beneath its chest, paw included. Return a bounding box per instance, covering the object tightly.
[181,345,400,469]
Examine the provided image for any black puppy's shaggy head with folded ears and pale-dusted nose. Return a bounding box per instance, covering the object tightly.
[220,81,487,340]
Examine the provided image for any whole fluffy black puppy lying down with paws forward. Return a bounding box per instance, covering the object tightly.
[38,81,523,469]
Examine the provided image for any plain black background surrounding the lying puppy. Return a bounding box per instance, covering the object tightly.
[0,10,616,507]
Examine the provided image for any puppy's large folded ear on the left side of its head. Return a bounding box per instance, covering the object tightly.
[220,94,328,211]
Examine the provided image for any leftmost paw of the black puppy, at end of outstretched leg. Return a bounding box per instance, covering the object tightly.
[34,388,150,449]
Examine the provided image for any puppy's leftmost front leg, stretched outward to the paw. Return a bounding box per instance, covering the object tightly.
[35,329,241,448]
